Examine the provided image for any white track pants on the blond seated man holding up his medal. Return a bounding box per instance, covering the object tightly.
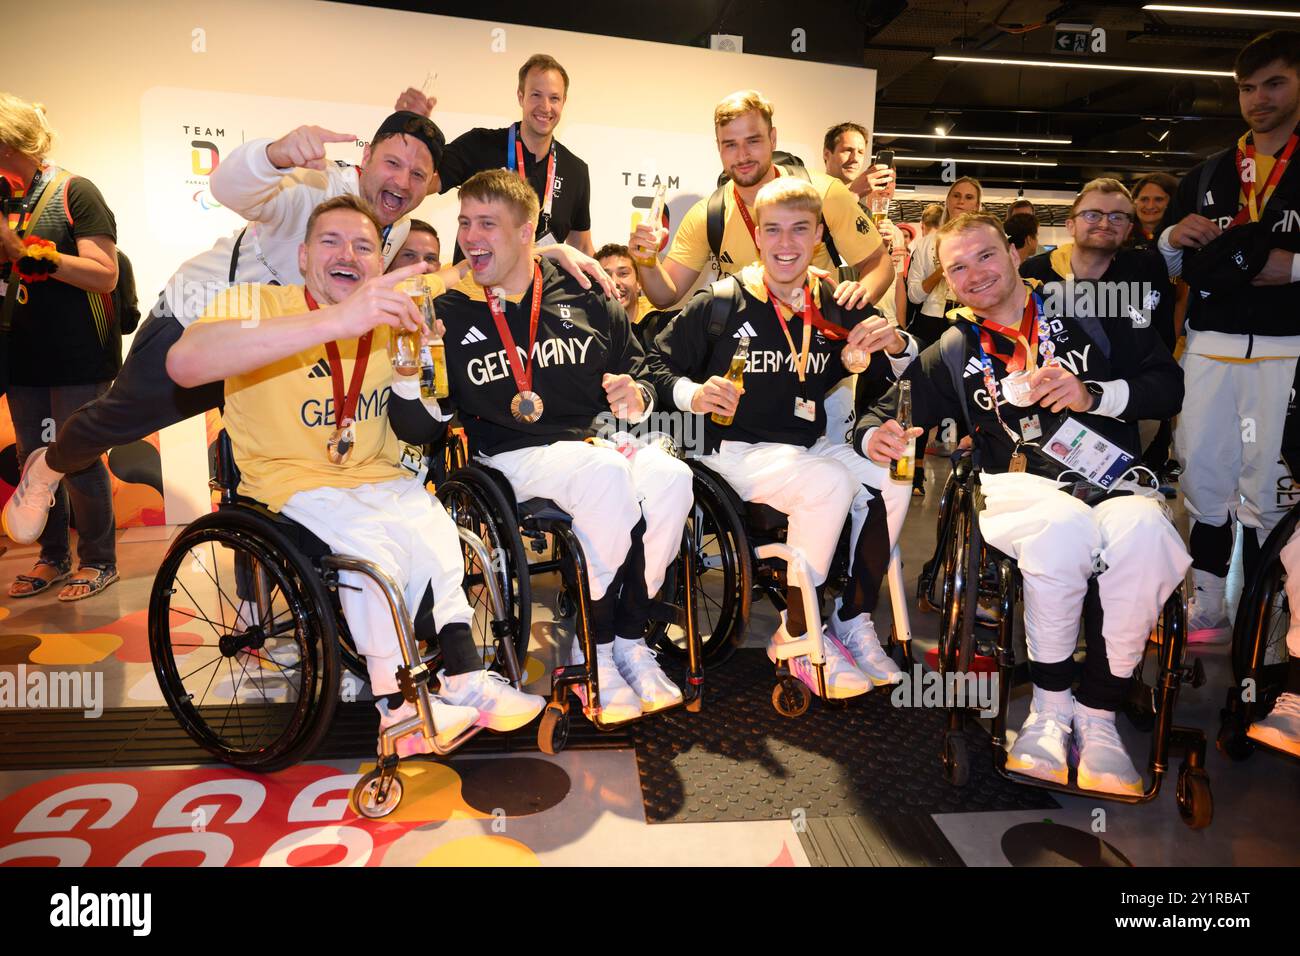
[699,436,911,585]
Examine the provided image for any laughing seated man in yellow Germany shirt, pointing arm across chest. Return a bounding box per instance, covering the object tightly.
[166,195,545,756]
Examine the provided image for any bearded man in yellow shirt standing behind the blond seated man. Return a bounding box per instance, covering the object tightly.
[628,90,893,308]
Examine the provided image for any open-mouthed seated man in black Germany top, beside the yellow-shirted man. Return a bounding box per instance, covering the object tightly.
[391,169,693,723]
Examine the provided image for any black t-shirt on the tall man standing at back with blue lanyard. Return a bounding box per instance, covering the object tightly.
[438,126,592,263]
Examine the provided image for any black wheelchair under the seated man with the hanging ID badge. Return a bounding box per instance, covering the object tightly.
[918,454,1213,829]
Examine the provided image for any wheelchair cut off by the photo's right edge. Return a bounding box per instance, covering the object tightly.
[1216,505,1300,761]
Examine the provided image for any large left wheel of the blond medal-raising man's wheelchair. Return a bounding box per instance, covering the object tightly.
[649,471,754,665]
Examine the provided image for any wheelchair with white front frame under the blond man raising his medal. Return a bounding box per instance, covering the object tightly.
[681,458,911,718]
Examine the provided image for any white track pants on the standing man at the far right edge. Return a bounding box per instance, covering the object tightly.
[1174,352,1296,544]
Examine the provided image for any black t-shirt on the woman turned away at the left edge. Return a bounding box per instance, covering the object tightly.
[9,176,122,388]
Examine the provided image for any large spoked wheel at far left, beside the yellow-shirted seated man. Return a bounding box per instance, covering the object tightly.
[148,507,339,773]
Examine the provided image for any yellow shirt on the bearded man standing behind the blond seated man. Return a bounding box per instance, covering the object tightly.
[668,170,883,277]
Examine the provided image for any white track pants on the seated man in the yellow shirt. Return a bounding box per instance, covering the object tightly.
[282,479,473,697]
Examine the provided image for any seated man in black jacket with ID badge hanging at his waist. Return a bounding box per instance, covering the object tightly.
[854,213,1191,793]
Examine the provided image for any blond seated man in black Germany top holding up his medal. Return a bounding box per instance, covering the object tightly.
[650,177,917,698]
